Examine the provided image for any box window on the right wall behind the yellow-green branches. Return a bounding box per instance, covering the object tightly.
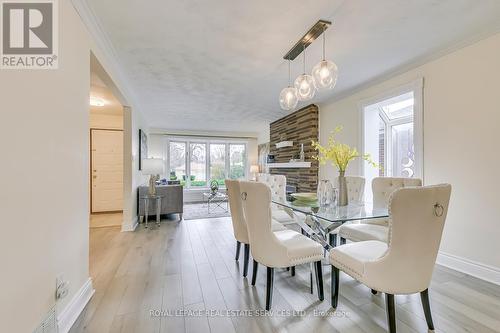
[362,80,423,200]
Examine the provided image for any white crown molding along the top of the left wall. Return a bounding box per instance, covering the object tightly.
[71,0,141,112]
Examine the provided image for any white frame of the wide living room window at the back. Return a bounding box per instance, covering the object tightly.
[163,136,249,191]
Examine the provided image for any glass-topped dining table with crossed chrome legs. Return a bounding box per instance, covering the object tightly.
[272,200,389,250]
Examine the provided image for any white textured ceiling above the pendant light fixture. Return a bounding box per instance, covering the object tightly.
[87,0,500,131]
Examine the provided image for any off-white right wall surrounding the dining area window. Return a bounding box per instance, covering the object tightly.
[320,34,500,283]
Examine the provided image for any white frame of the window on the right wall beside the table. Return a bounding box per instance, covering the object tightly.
[358,78,425,182]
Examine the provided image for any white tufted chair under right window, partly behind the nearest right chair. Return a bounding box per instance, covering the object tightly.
[338,177,422,244]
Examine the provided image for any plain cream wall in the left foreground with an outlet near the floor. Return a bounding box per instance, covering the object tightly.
[0,1,90,332]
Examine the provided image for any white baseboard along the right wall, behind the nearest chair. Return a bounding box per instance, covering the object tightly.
[436,252,500,285]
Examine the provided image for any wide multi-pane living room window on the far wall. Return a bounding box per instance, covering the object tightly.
[165,137,247,188]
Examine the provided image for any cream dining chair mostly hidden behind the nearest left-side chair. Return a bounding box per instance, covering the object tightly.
[224,179,286,277]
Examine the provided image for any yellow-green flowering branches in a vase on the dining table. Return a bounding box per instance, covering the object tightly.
[312,126,378,206]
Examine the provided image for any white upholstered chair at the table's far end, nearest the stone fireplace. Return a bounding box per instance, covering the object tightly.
[257,173,295,224]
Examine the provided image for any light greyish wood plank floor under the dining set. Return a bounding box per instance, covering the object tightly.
[71,218,500,333]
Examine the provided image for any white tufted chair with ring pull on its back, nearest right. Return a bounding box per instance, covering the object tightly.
[330,184,451,333]
